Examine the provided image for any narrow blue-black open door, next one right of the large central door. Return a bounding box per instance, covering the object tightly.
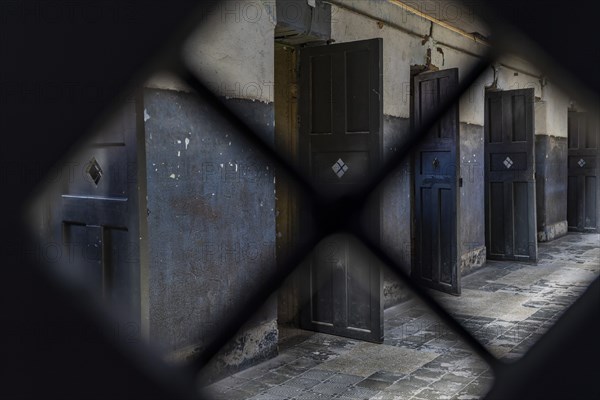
[411,68,460,294]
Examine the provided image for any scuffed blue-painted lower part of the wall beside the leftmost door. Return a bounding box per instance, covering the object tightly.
[144,89,276,368]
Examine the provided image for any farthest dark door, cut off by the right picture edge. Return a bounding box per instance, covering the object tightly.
[567,111,600,232]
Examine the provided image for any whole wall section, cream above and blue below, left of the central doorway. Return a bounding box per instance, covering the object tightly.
[144,1,278,375]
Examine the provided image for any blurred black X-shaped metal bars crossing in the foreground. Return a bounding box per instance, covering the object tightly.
[173,44,498,382]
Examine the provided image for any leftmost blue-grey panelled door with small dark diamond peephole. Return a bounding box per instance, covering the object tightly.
[56,99,140,324]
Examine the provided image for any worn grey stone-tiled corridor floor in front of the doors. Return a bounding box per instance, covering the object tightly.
[206,233,600,400]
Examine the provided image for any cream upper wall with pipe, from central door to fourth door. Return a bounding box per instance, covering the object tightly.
[331,0,493,125]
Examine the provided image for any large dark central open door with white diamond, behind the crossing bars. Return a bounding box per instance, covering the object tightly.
[299,39,383,342]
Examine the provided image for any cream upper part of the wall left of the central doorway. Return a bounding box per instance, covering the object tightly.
[183,0,276,103]
